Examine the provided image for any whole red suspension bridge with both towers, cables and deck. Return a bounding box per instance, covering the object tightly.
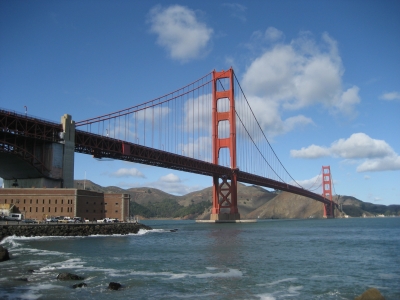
[0,69,336,220]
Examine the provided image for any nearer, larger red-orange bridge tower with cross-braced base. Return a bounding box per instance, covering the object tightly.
[210,68,240,220]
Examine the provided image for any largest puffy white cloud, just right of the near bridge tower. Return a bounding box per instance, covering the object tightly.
[242,27,361,135]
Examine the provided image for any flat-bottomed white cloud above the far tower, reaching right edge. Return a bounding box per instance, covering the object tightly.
[290,133,400,172]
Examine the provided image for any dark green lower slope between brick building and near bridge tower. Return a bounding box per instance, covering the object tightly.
[130,199,211,218]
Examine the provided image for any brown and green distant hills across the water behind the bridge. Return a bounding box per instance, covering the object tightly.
[75,180,400,219]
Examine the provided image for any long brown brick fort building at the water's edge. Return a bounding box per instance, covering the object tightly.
[0,188,130,221]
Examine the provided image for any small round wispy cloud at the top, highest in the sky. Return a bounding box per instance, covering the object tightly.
[149,5,213,62]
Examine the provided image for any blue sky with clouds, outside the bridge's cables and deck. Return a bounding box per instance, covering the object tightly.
[0,0,400,205]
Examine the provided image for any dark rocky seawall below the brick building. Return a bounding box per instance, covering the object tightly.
[0,223,152,241]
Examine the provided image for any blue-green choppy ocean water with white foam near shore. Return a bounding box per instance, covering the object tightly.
[0,218,400,300]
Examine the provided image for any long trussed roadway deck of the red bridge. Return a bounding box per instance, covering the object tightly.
[0,110,331,204]
